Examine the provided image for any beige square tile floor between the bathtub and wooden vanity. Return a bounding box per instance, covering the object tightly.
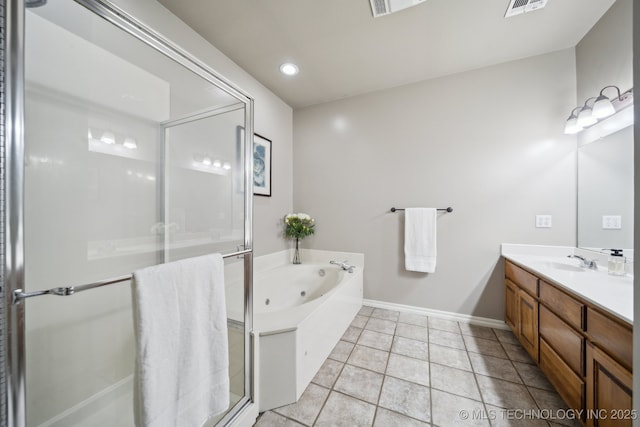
[255,306,580,427]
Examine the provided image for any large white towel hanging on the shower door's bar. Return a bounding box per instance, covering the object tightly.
[132,254,229,427]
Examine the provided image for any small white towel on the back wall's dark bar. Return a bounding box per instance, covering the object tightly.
[404,208,438,273]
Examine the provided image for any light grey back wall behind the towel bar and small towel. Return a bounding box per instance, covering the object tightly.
[294,49,576,319]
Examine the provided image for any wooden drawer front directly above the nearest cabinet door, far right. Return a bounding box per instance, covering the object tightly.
[587,307,633,370]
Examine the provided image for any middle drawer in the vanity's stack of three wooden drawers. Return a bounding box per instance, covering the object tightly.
[539,305,584,376]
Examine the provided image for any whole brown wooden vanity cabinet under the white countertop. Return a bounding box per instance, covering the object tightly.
[505,260,633,427]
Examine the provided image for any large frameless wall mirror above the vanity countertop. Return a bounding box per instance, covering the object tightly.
[578,115,634,257]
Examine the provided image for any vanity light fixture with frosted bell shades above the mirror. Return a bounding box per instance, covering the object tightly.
[564,86,633,135]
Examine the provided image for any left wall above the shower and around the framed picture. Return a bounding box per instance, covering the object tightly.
[114,0,293,255]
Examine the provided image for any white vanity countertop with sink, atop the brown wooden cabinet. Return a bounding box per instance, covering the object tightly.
[502,243,633,324]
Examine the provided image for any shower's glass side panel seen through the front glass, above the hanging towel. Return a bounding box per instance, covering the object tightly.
[165,110,244,260]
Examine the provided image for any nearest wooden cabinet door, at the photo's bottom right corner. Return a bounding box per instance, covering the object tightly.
[586,345,634,427]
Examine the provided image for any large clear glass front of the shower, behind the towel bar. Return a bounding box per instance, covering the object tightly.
[25,0,247,426]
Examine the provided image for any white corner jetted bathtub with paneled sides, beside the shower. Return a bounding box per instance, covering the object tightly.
[253,250,364,412]
